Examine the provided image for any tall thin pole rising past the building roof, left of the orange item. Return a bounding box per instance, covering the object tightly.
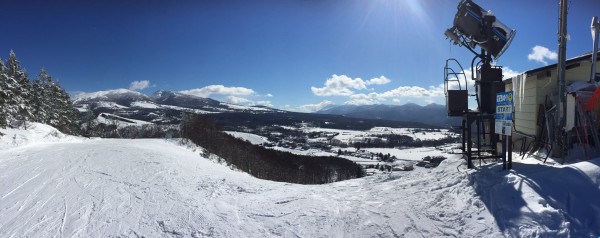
[553,0,567,157]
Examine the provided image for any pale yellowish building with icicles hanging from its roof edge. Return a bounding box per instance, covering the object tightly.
[504,53,600,146]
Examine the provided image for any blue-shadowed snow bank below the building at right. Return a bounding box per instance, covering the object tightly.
[469,159,600,237]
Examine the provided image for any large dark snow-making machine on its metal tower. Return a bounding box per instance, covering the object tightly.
[444,0,516,168]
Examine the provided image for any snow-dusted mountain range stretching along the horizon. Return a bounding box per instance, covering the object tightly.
[73,89,448,129]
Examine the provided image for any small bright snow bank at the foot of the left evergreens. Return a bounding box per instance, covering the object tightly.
[0,122,83,150]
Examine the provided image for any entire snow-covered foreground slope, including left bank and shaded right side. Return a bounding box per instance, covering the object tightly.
[0,124,600,237]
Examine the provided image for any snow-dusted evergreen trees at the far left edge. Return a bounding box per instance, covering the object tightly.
[0,50,79,134]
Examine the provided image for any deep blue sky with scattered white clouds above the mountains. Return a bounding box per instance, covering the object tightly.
[0,0,600,111]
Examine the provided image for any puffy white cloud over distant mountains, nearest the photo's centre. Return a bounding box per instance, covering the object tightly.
[310,74,367,97]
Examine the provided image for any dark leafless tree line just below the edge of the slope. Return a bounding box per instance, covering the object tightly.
[180,114,364,184]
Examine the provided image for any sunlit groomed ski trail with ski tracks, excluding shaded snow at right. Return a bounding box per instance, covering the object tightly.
[0,139,502,237]
